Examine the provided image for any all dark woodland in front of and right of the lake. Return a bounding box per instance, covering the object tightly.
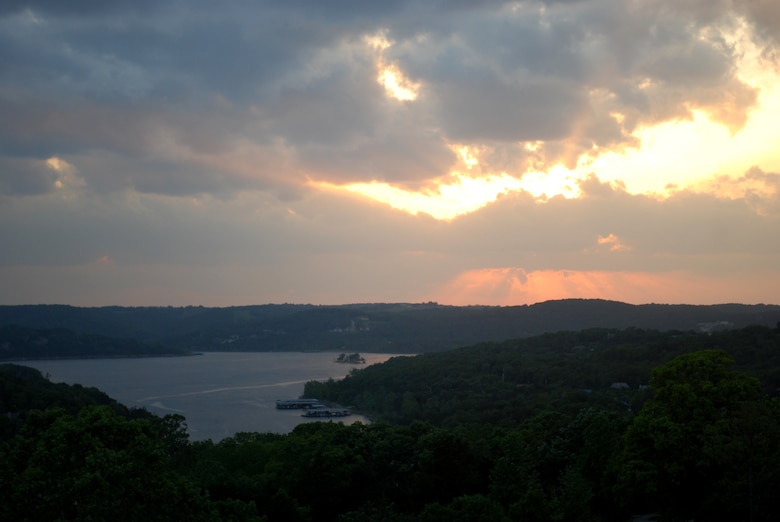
[0,327,780,522]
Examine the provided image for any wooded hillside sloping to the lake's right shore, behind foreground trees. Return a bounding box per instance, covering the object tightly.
[304,326,780,427]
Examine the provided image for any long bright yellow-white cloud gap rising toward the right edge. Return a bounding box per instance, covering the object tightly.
[338,52,780,219]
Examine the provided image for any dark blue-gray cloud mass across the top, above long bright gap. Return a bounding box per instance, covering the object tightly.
[0,0,776,198]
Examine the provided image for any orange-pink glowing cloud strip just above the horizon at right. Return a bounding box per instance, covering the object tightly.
[431,268,780,306]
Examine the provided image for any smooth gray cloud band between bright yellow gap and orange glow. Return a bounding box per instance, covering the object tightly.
[0,169,780,273]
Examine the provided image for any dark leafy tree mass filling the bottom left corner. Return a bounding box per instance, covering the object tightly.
[0,406,212,521]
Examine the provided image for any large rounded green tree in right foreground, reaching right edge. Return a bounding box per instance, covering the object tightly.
[622,350,780,520]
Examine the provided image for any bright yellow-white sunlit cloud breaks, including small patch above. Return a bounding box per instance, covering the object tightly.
[323,19,780,220]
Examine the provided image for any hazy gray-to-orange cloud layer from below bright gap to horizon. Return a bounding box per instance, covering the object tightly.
[0,164,780,304]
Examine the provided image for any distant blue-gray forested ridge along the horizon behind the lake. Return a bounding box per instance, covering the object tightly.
[0,299,780,353]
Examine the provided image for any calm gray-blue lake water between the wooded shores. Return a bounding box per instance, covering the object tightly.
[18,352,402,441]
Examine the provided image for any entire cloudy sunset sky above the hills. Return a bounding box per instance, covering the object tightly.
[0,0,780,306]
